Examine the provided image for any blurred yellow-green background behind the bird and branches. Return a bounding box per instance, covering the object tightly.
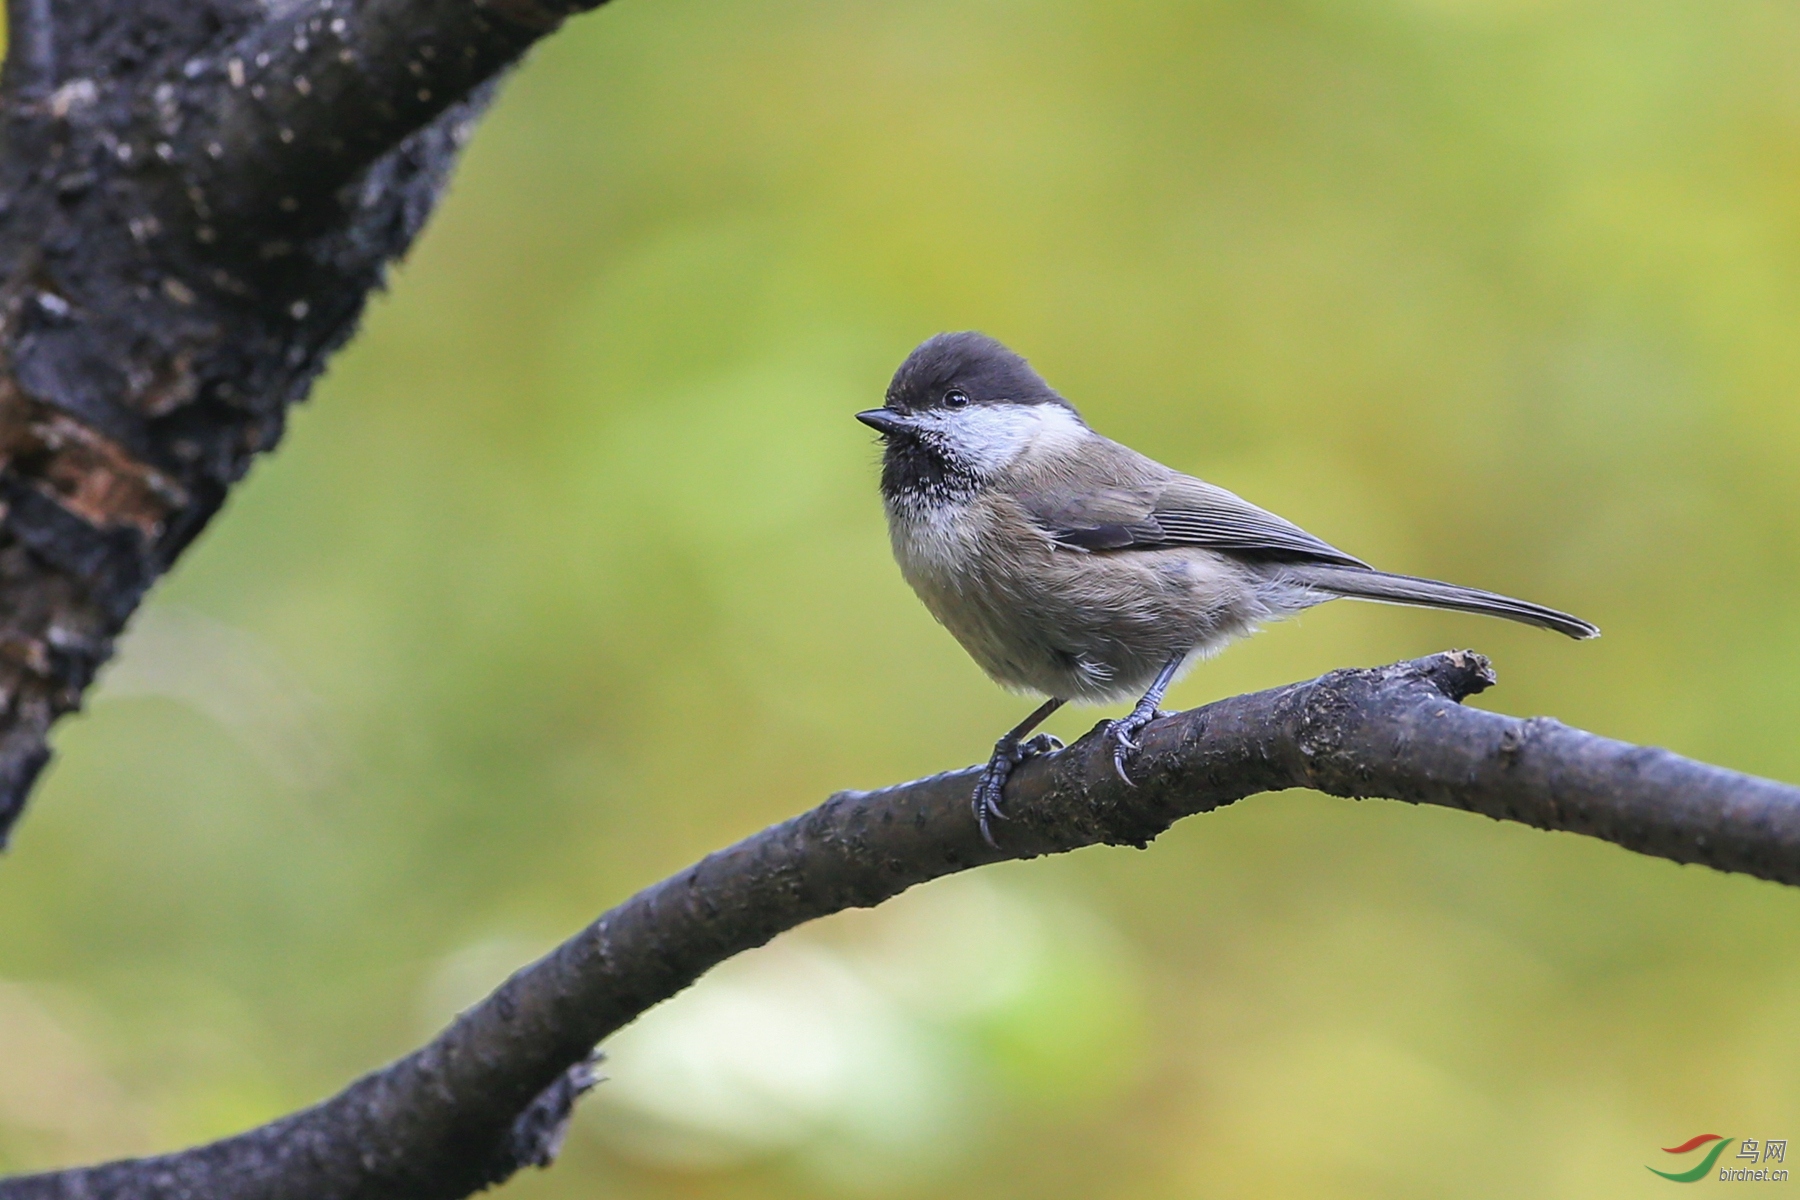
[0,0,1800,1200]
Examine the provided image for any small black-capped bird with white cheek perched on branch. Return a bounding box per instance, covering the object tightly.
[857,333,1600,846]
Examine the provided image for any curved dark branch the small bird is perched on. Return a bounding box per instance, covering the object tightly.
[0,651,1800,1200]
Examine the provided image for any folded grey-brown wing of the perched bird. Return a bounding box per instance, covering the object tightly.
[1026,471,1368,567]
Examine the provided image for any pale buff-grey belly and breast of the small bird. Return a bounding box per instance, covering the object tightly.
[891,500,1260,703]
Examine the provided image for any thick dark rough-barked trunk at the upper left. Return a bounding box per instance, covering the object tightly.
[0,0,612,844]
